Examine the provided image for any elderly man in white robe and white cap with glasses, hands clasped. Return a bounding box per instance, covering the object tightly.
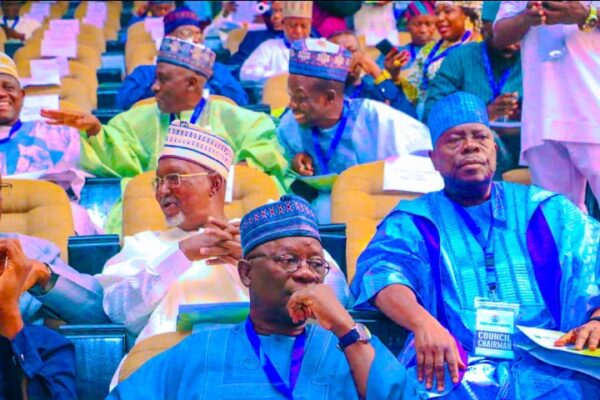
[96,121,348,341]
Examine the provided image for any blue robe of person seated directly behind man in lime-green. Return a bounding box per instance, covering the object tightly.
[117,62,248,110]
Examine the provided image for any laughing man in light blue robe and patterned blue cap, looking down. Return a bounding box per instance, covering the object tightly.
[277,39,431,223]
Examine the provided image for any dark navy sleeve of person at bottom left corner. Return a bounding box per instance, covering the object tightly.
[11,325,77,400]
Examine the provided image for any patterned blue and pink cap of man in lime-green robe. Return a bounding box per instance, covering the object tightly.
[156,36,216,79]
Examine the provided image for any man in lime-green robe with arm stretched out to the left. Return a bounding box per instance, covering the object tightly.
[42,37,287,233]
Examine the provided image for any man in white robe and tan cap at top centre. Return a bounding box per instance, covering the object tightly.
[240,1,312,82]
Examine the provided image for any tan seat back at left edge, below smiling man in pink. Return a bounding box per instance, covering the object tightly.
[0,179,75,262]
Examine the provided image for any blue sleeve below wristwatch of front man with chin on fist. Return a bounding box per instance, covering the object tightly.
[366,337,417,400]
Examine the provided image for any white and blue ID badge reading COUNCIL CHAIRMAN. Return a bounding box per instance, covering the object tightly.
[473,297,519,360]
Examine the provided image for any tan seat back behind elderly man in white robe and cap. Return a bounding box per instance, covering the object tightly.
[123,165,279,236]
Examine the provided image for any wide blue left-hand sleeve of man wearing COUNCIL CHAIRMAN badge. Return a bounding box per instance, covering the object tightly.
[350,212,433,309]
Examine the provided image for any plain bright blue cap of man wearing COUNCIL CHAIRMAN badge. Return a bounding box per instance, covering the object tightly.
[427,92,490,147]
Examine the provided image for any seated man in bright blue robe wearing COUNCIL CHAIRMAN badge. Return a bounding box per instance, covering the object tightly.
[352,92,600,400]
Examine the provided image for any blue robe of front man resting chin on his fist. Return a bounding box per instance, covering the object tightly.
[108,323,416,400]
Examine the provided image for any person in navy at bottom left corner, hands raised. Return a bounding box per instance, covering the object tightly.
[0,240,77,400]
